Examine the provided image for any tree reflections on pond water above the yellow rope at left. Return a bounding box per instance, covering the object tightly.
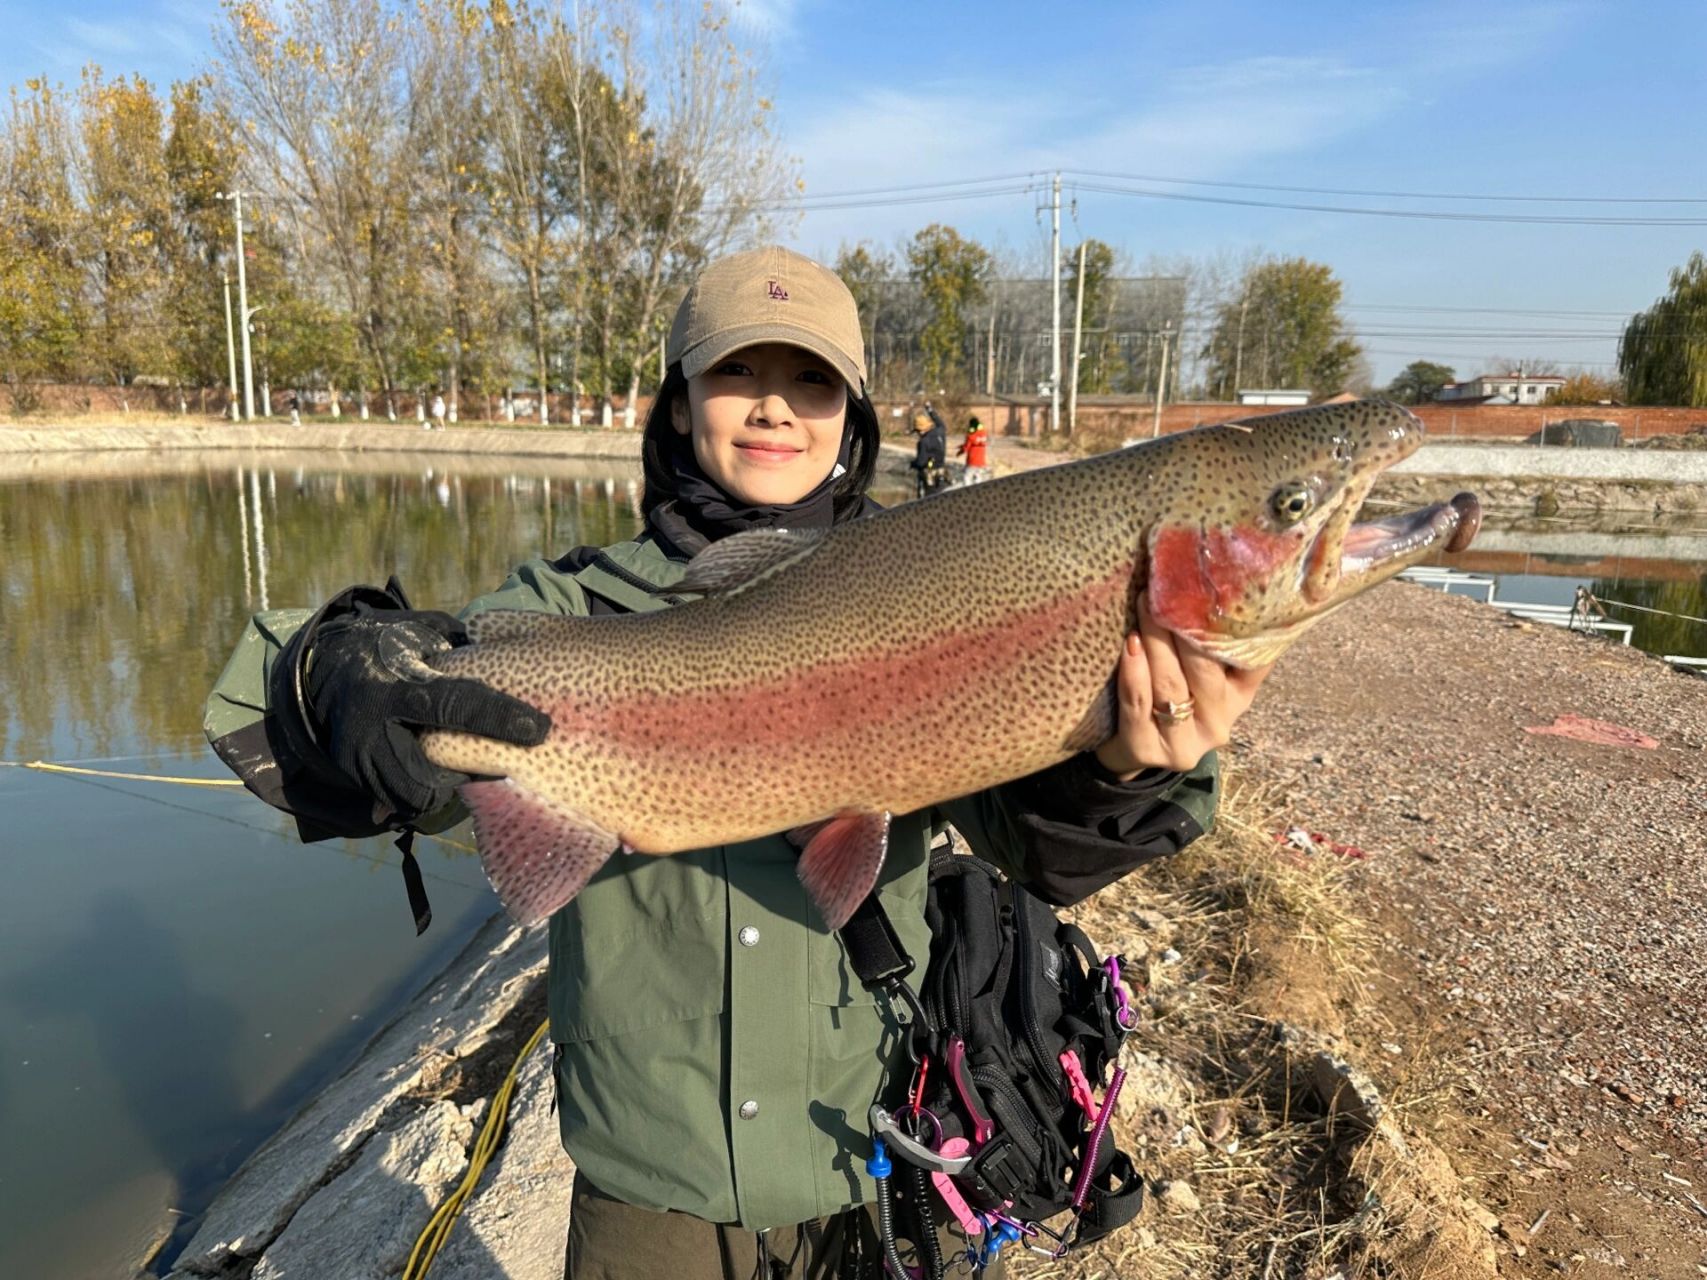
[0,461,640,759]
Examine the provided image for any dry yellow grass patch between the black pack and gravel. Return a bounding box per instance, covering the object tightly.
[1011,771,1490,1280]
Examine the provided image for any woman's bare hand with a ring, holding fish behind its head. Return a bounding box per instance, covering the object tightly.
[1096,596,1273,782]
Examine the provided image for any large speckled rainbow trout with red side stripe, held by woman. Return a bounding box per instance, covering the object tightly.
[423,401,1480,927]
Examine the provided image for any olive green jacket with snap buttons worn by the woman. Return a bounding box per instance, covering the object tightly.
[207,534,1217,1231]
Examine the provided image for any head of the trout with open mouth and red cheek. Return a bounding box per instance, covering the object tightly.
[1145,401,1482,667]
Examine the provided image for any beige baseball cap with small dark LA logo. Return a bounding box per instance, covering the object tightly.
[664,244,865,394]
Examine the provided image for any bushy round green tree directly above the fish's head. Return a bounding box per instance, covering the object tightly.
[1203,258,1362,398]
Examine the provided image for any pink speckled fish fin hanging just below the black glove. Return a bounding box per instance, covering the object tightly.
[457,778,621,925]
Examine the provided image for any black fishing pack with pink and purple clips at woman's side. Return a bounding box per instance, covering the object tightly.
[840,852,1144,1280]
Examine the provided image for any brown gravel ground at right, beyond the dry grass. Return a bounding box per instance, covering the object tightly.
[1238,582,1707,1275]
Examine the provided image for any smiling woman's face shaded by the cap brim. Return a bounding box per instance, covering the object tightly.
[671,343,848,505]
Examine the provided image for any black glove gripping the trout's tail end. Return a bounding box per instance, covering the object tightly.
[306,604,551,823]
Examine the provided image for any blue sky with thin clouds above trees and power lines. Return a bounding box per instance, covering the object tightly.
[0,0,1707,381]
